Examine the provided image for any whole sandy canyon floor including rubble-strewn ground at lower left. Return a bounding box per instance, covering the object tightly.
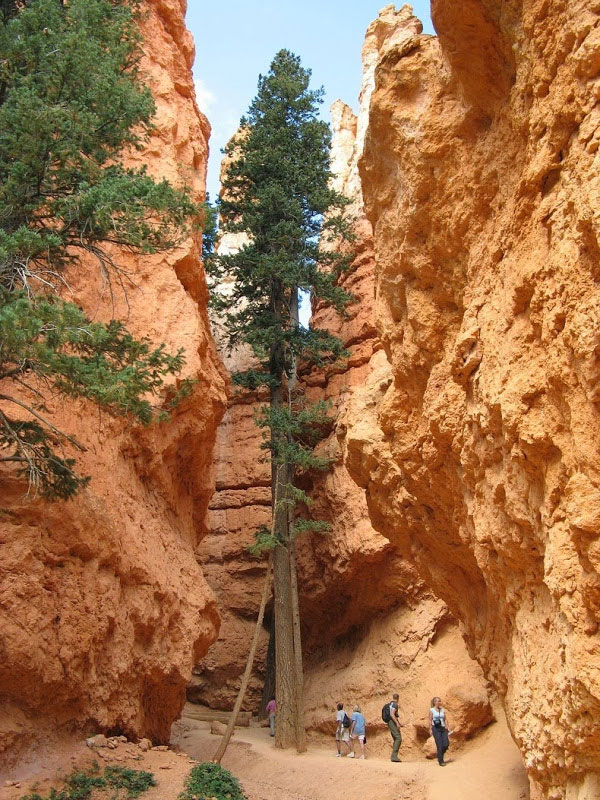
[0,714,529,800]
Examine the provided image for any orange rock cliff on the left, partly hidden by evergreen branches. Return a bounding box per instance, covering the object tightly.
[0,0,227,763]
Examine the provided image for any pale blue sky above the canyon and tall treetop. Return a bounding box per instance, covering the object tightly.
[186,0,433,198]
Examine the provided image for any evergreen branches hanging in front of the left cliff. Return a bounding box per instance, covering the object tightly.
[0,0,198,499]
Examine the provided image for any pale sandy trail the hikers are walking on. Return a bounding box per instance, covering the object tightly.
[174,716,529,800]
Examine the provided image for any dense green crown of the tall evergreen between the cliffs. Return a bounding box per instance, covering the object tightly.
[211,50,350,370]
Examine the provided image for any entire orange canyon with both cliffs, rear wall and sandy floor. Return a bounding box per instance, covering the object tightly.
[0,0,600,800]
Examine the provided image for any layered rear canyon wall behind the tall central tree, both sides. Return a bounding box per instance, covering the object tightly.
[188,15,494,757]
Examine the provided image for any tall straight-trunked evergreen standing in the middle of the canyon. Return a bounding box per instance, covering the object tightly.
[208,50,350,751]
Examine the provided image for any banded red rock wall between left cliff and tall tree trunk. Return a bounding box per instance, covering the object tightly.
[188,396,271,710]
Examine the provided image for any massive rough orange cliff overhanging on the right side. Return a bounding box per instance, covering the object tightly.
[344,0,600,800]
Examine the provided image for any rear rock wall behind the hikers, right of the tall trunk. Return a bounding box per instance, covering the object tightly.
[298,40,494,757]
